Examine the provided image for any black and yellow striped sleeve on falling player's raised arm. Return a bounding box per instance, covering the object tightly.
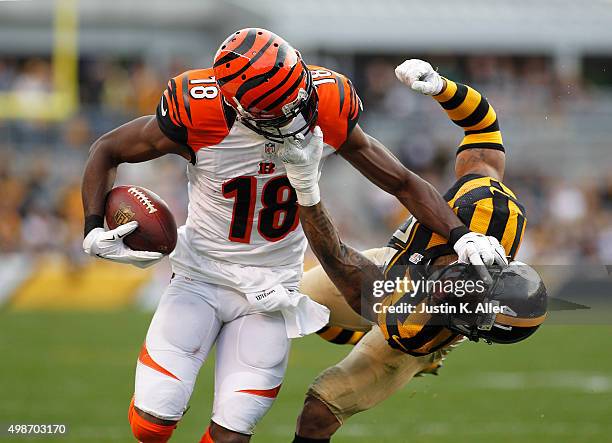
[434,79,504,153]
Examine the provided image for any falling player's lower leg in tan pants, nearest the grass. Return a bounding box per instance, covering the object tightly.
[294,327,452,443]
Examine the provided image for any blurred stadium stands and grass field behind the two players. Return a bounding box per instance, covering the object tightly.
[0,0,612,442]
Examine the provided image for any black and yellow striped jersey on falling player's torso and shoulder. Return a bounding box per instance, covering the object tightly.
[378,174,527,356]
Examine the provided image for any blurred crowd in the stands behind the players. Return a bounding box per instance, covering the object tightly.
[0,56,612,264]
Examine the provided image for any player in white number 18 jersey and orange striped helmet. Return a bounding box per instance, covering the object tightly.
[82,28,502,443]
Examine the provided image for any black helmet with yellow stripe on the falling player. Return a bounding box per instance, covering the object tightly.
[427,261,546,344]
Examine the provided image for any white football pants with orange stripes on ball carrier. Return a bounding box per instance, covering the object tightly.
[134,276,289,434]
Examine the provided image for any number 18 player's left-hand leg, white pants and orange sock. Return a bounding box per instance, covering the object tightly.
[129,276,221,443]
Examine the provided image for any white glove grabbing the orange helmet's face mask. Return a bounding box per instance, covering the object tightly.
[277,126,323,206]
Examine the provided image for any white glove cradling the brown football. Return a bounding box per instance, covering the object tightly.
[83,220,164,268]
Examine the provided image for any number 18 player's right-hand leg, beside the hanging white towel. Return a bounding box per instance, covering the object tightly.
[202,312,289,443]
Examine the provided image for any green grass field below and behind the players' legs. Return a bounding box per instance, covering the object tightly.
[0,311,612,443]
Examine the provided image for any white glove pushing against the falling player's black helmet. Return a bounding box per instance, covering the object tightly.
[454,231,508,266]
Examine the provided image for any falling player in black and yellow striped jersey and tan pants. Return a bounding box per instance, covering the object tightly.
[280,59,546,443]
